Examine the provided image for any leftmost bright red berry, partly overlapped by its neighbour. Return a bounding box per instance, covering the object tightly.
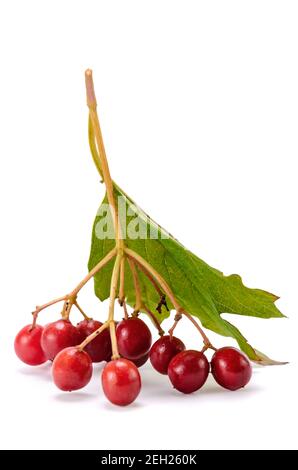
[14,325,47,366]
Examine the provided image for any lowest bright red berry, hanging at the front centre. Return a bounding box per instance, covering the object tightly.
[101,358,141,406]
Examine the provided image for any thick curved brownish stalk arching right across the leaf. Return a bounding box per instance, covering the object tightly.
[125,248,215,349]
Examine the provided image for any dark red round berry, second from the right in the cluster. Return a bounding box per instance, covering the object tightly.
[168,350,209,393]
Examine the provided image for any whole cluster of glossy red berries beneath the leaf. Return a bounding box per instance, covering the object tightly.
[14,317,252,405]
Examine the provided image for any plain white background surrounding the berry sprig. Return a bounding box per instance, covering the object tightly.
[0,0,298,449]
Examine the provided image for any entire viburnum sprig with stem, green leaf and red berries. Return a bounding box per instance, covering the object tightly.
[14,70,268,408]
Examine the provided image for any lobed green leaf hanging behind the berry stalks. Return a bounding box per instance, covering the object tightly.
[88,185,284,364]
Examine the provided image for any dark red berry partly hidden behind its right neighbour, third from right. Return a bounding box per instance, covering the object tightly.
[150,335,185,375]
